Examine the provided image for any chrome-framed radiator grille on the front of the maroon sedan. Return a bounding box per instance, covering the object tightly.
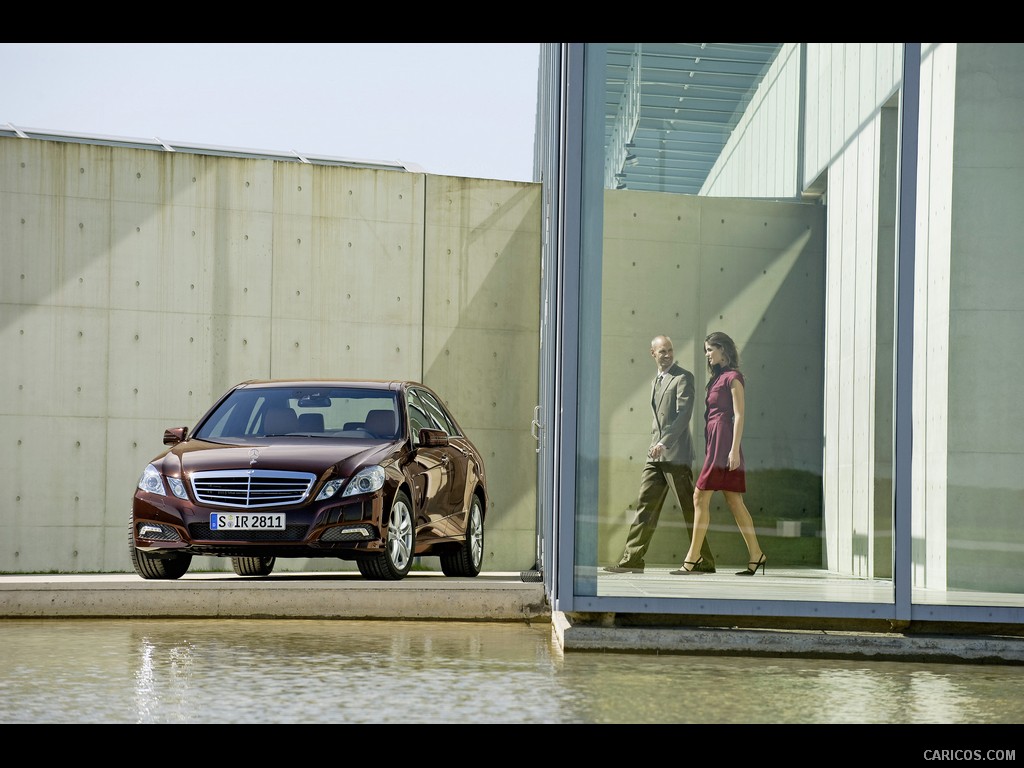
[191,469,316,509]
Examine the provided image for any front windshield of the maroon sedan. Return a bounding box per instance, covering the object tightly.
[193,387,398,440]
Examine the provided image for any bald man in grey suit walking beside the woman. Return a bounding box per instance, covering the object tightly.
[604,336,715,573]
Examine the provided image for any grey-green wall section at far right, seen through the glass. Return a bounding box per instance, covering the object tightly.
[926,43,1024,592]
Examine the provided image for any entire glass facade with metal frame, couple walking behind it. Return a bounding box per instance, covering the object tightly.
[541,43,1024,627]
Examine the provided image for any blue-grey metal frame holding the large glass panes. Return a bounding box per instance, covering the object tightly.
[539,43,1024,627]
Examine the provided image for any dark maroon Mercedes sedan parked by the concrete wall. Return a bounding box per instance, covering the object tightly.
[129,379,487,580]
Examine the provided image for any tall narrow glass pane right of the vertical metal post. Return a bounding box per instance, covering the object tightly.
[901,43,1024,615]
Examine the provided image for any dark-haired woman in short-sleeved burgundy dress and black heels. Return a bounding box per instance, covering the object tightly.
[669,331,768,575]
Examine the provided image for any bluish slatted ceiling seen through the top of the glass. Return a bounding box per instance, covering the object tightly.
[604,43,782,195]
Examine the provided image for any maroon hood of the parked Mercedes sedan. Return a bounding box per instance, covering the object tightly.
[159,438,398,476]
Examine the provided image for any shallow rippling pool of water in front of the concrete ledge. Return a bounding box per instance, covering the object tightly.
[0,620,1024,724]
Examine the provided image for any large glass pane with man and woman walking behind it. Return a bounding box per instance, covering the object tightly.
[574,44,895,603]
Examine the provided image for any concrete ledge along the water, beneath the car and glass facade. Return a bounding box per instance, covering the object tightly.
[0,571,1024,665]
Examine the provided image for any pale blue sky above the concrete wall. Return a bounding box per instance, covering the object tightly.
[0,43,540,181]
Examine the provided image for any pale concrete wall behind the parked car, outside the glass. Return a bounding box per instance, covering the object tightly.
[0,137,541,572]
